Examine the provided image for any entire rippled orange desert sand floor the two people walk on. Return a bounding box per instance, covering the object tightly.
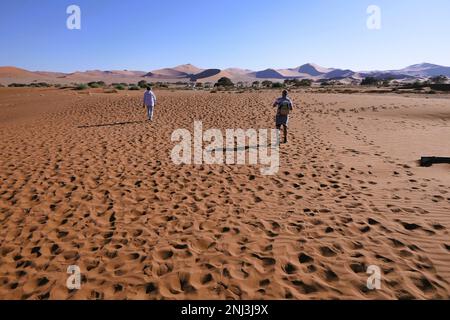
[0,88,450,299]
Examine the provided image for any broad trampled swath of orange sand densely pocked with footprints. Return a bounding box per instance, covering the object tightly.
[0,93,450,299]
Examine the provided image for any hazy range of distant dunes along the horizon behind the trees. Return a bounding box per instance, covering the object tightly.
[0,63,450,84]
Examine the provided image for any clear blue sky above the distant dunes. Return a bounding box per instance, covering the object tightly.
[0,0,450,72]
